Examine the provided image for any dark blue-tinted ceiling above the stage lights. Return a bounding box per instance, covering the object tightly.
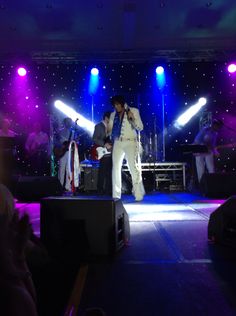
[0,0,236,62]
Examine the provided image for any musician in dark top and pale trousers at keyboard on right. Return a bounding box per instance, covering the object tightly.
[194,119,223,183]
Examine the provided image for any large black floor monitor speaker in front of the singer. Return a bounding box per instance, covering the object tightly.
[40,197,129,255]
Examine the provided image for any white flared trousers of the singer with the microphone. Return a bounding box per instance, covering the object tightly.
[112,140,145,199]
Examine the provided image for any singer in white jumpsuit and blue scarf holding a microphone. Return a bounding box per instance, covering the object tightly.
[108,95,145,201]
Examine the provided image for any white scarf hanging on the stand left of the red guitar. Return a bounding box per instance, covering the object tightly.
[68,140,80,188]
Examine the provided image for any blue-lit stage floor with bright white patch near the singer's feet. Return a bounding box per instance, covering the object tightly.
[17,192,236,316]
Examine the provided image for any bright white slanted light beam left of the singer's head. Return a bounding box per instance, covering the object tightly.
[54,100,94,136]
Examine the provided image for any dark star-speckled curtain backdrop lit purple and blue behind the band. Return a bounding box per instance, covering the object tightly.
[0,62,236,173]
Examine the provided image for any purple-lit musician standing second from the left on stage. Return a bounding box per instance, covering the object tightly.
[25,122,49,176]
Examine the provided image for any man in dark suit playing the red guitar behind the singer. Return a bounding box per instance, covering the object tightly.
[93,112,112,195]
